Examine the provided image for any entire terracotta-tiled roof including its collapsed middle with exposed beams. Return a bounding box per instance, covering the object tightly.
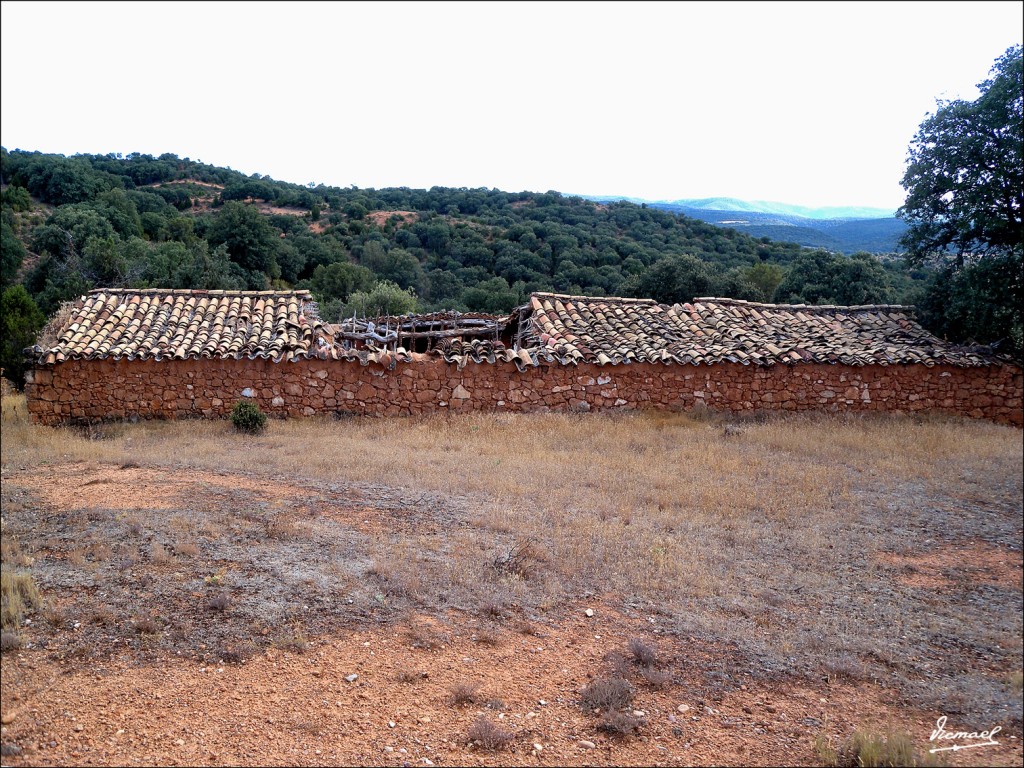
[27,289,1009,370]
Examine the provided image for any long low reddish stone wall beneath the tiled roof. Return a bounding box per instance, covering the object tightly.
[19,355,1024,426]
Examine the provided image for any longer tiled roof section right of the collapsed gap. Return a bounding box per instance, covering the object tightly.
[525,294,996,367]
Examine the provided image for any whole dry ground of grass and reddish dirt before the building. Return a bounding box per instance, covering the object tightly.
[0,409,1024,766]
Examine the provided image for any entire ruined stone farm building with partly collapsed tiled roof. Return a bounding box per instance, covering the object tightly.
[26,289,1022,426]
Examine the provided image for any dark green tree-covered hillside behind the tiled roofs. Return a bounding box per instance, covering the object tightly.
[0,150,924,385]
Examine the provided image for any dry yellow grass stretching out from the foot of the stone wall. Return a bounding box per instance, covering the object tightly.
[3,396,1021,597]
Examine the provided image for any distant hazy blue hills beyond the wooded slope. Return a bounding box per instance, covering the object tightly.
[581,196,906,254]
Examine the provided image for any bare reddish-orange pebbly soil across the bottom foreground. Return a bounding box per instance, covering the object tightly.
[3,604,1022,765]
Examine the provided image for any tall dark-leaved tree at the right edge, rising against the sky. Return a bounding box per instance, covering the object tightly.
[898,45,1024,357]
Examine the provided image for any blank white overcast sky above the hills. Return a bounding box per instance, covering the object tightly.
[0,1,1024,208]
